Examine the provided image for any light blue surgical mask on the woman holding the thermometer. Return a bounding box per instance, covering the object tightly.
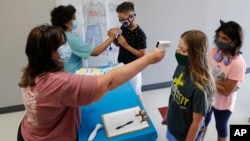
[57,43,72,63]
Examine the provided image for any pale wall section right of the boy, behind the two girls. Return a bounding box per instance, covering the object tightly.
[132,0,250,85]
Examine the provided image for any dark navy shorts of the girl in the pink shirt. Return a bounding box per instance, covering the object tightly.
[205,107,232,138]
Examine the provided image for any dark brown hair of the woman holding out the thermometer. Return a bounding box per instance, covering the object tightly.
[18,24,66,88]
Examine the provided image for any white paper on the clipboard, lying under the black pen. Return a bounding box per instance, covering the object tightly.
[102,106,149,138]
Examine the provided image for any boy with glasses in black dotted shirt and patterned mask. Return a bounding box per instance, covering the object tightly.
[114,2,147,100]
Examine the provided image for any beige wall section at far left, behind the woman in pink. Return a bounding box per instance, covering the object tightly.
[0,0,55,108]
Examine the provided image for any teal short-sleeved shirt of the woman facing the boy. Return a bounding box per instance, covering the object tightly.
[64,32,94,73]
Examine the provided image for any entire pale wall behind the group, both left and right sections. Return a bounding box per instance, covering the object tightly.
[0,0,250,108]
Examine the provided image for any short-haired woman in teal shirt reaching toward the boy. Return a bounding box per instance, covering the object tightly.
[50,5,119,73]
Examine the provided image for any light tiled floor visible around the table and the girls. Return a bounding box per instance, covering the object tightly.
[0,74,250,141]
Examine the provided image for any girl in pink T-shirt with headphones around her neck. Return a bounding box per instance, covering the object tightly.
[203,21,246,141]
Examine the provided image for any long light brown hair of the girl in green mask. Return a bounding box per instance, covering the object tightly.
[181,30,215,93]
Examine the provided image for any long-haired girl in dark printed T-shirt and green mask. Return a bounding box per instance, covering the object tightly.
[162,30,215,141]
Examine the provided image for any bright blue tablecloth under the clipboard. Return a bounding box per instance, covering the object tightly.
[78,82,158,141]
